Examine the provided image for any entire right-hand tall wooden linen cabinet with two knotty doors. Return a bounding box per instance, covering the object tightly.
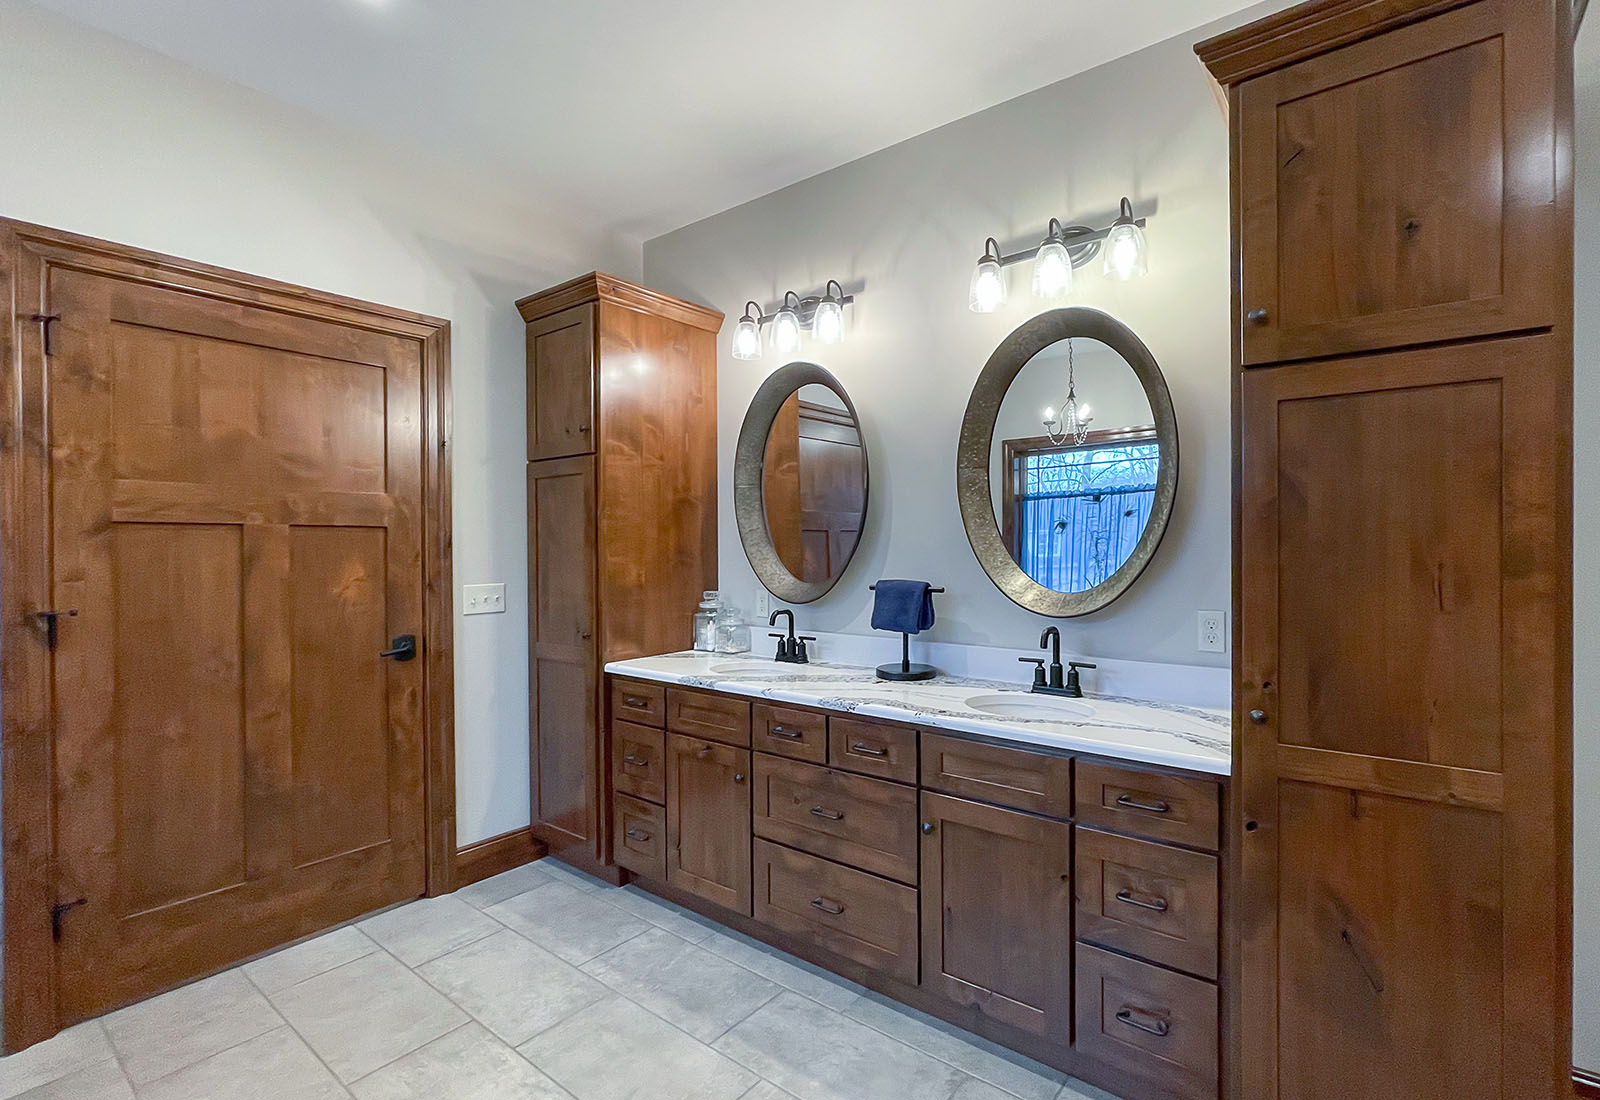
[1197,0,1573,1100]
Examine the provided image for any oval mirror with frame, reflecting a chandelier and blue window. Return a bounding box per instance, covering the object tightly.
[957,309,1178,619]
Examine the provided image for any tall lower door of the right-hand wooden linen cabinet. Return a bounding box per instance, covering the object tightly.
[1235,336,1571,1100]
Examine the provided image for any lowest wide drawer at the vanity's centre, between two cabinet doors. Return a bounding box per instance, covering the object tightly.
[755,839,918,983]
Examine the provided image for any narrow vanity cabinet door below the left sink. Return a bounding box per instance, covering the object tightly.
[667,734,750,916]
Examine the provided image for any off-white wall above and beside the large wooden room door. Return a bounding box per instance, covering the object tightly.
[0,0,640,843]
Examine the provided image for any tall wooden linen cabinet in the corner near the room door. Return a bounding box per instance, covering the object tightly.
[517,273,722,881]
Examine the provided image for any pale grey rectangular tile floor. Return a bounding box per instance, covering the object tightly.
[0,860,1115,1100]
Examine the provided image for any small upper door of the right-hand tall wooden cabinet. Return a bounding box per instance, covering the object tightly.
[1235,0,1571,366]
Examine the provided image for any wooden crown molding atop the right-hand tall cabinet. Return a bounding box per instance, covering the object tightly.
[1195,0,1472,85]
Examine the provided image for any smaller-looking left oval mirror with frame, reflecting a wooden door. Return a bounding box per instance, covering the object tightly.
[733,363,867,603]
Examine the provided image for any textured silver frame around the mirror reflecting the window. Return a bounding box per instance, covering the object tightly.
[955,307,1178,619]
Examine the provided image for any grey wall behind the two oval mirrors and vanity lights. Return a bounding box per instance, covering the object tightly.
[645,14,1230,665]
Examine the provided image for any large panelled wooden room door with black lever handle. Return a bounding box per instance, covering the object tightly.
[48,267,426,1023]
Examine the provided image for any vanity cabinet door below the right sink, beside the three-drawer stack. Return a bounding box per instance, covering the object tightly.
[922,793,1072,1042]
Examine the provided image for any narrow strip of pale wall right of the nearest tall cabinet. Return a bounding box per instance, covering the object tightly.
[1573,11,1600,1073]
